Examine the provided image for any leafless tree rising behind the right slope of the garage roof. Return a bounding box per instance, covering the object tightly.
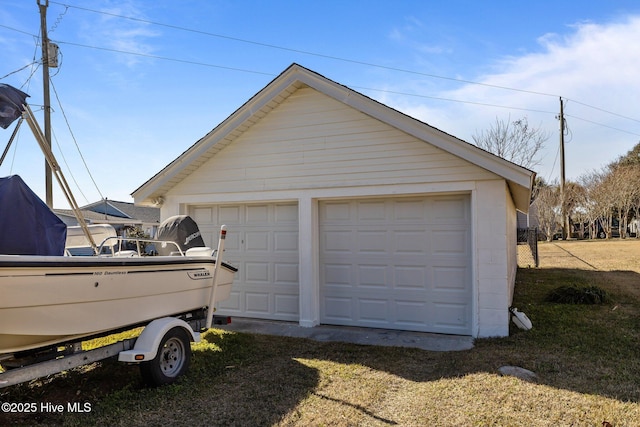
[473,116,550,169]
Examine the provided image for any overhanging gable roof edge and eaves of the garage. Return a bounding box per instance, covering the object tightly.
[131,64,535,212]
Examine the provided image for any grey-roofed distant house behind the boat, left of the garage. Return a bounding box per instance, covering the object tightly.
[54,199,160,237]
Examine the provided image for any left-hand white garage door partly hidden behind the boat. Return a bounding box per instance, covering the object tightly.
[189,203,299,320]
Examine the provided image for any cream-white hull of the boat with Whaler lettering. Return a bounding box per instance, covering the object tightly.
[0,255,237,354]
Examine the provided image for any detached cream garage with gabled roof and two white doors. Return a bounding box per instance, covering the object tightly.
[132,64,535,337]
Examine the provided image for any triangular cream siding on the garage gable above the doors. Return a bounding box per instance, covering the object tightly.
[171,88,496,199]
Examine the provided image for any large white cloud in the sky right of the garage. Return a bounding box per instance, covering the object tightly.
[383,16,640,179]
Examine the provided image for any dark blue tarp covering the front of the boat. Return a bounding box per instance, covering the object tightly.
[0,175,67,255]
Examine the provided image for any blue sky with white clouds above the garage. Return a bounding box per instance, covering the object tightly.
[0,0,640,207]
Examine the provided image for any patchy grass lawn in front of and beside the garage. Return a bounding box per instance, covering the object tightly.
[0,240,640,427]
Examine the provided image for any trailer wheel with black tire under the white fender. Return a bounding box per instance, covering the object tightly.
[140,327,191,387]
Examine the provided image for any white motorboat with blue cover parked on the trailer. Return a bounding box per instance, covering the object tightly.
[0,84,237,361]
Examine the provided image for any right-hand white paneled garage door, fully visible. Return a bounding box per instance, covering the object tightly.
[320,195,472,335]
